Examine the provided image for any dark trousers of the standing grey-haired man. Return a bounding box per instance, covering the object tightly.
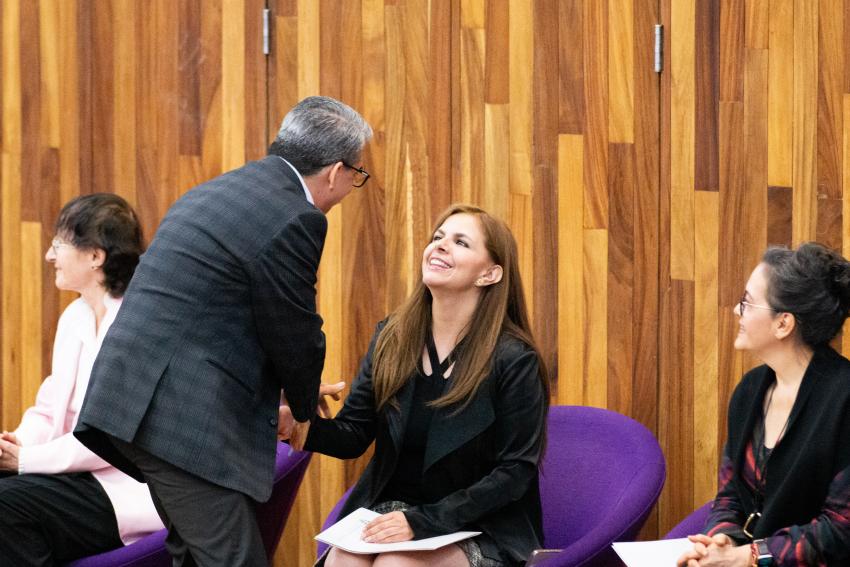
[106,437,269,567]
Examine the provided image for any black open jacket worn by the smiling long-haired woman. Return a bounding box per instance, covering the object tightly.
[305,325,548,564]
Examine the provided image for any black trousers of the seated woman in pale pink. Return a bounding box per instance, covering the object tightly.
[0,472,123,567]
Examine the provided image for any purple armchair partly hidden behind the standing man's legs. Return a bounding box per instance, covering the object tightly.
[66,443,312,567]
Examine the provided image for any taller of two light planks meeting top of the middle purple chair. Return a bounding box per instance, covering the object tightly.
[557,134,585,405]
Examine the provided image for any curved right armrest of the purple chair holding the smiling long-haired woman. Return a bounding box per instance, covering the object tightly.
[528,461,665,567]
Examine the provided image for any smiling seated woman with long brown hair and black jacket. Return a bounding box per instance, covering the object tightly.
[281,205,548,567]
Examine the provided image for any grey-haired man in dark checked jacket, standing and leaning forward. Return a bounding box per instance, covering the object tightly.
[74,97,372,566]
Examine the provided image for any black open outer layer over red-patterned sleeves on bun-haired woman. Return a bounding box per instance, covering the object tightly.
[708,347,850,565]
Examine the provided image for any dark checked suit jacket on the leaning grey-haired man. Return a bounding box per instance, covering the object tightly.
[74,156,327,500]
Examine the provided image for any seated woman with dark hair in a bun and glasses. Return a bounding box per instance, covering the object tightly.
[678,243,850,567]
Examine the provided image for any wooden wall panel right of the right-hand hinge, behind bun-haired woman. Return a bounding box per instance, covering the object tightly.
[658,0,849,533]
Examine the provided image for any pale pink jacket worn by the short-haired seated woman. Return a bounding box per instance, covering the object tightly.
[15,295,163,544]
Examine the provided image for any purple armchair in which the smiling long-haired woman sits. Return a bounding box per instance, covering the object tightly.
[318,406,666,567]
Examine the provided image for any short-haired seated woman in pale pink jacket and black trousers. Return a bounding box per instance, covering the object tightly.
[0,193,163,567]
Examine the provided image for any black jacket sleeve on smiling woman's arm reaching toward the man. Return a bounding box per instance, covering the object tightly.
[304,324,383,459]
